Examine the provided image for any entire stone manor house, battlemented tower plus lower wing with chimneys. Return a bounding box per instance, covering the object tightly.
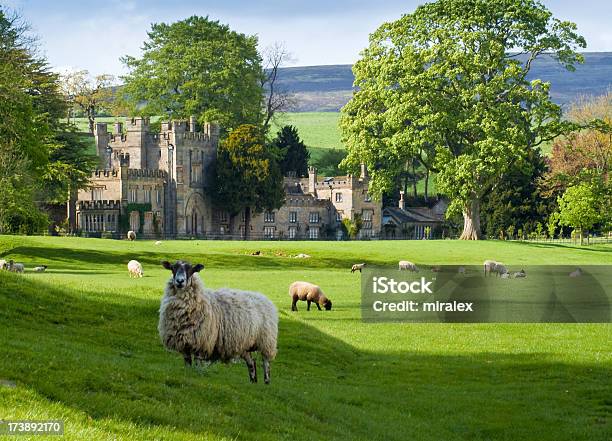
[74,117,382,239]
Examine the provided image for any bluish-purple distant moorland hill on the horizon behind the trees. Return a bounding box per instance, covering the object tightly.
[279,52,612,112]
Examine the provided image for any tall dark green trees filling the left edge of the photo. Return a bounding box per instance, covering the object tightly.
[0,7,92,233]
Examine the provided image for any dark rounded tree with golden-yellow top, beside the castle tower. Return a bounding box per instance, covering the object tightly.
[211,124,285,239]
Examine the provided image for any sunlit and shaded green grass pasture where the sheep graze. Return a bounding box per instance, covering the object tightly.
[0,236,612,441]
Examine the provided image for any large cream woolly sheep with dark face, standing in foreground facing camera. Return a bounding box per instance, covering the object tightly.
[157,260,278,384]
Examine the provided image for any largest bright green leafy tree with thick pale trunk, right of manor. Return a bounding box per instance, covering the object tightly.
[341,0,586,239]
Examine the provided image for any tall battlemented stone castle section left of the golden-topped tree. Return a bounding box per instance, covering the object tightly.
[76,117,219,237]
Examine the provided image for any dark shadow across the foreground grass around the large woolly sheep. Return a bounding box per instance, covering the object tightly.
[0,274,612,440]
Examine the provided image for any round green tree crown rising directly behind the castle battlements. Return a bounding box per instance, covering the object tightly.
[122,16,263,130]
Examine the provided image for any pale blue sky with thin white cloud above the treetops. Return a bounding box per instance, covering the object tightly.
[0,0,612,74]
